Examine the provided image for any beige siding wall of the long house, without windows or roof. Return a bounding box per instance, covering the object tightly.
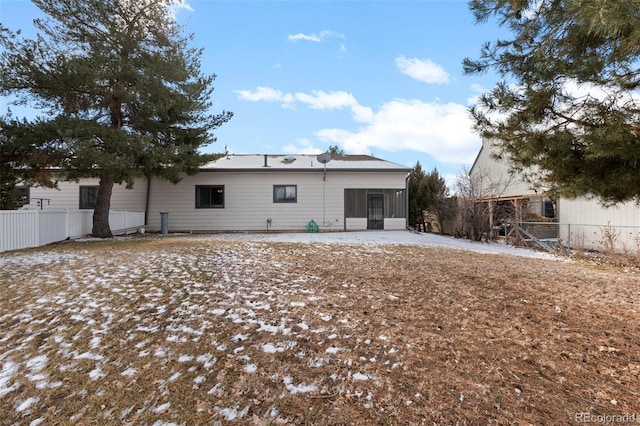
[148,171,406,232]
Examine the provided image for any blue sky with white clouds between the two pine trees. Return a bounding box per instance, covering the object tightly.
[0,0,504,186]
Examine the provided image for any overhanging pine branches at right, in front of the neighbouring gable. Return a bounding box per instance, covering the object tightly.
[464,0,640,204]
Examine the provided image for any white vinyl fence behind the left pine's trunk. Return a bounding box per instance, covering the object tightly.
[0,209,144,252]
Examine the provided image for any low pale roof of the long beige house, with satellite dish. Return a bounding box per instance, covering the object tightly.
[200,154,411,173]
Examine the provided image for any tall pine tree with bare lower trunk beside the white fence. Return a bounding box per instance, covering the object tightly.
[0,0,232,237]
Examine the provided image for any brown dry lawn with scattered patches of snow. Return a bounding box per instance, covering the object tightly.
[0,236,640,426]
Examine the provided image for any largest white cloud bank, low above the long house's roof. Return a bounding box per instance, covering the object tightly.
[236,87,481,165]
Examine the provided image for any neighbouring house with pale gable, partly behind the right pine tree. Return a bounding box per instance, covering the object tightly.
[470,140,640,253]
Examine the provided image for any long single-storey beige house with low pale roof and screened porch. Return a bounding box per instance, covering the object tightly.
[25,154,411,232]
